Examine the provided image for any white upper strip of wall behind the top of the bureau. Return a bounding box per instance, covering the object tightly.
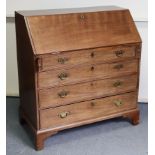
[6,0,147,21]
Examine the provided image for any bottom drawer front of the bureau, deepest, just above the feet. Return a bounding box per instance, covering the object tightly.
[40,92,137,128]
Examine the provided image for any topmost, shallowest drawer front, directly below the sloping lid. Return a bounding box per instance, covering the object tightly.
[39,45,135,71]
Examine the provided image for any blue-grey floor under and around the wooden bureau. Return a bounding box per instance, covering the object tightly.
[6,97,148,155]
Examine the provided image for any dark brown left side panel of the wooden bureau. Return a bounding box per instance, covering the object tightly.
[15,13,38,129]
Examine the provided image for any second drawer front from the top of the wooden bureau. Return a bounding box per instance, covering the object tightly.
[38,60,138,88]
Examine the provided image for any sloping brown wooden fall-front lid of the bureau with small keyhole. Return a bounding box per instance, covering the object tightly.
[25,6,141,54]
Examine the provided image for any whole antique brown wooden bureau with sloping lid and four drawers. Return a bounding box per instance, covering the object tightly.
[15,6,141,150]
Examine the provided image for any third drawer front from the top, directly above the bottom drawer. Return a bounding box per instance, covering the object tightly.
[39,75,137,108]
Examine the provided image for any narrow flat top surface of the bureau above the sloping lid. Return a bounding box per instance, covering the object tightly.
[15,5,127,17]
